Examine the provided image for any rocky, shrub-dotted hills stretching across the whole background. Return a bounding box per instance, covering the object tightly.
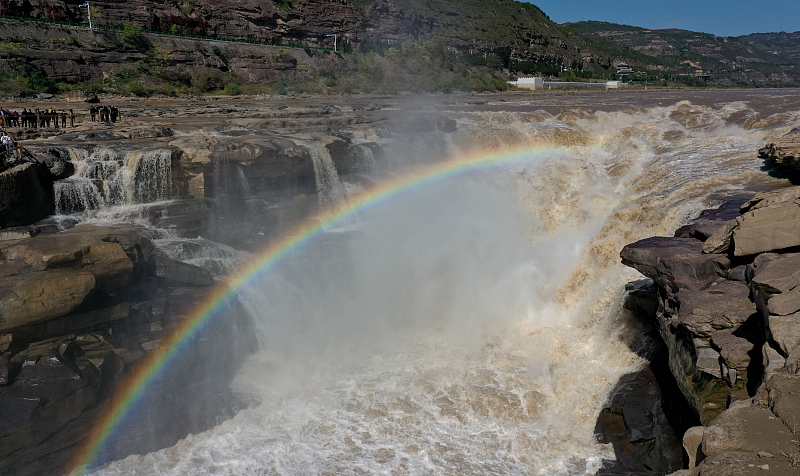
[0,0,800,94]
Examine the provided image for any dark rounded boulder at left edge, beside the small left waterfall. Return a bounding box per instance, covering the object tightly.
[0,163,55,228]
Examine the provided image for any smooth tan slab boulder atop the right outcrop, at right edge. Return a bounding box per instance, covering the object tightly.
[733,204,800,256]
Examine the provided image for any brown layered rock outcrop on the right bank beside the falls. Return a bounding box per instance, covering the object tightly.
[621,188,800,475]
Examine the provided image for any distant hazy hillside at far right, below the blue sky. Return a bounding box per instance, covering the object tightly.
[565,22,800,86]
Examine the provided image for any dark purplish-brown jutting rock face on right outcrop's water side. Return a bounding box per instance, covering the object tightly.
[621,230,756,422]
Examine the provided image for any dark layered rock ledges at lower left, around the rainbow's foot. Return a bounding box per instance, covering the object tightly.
[0,225,254,475]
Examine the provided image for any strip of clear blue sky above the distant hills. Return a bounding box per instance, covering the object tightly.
[530,0,800,35]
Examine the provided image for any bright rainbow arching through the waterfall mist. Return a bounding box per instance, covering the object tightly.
[68,140,563,475]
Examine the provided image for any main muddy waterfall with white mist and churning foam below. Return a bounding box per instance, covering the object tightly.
[92,99,792,476]
